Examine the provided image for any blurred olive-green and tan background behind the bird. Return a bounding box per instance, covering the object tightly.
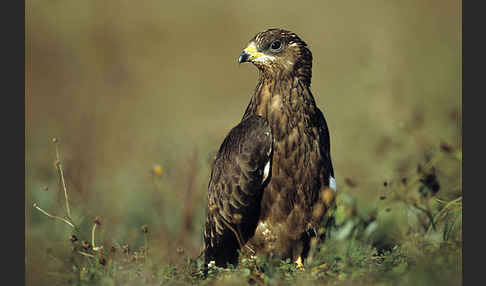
[25,0,462,284]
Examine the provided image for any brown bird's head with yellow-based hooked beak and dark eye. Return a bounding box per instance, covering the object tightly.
[238,29,312,84]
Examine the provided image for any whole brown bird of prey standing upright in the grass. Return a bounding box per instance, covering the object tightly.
[204,29,337,267]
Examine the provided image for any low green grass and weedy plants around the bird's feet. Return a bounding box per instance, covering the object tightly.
[27,143,462,285]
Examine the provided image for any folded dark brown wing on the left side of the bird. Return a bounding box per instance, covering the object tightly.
[204,116,272,266]
